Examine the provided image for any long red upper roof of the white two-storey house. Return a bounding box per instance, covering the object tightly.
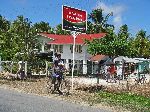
[39,33,106,44]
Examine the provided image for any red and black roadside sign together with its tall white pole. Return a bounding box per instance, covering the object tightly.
[62,6,87,91]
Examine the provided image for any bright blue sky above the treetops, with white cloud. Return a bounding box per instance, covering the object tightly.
[0,0,150,35]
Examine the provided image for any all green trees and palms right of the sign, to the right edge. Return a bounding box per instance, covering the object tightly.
[86,9,150,58]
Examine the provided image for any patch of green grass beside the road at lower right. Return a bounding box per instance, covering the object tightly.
[95,91,150,112]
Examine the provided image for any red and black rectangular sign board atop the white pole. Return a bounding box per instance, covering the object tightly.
[62,6,87,32]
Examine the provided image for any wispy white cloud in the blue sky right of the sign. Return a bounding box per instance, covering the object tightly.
[96,2,126,30]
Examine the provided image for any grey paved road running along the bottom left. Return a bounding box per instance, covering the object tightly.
[0,88,108,112]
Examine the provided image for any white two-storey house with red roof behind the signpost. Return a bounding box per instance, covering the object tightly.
[37,33,105,74]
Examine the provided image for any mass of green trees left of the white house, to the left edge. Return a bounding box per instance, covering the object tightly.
[0,16,51,61]
